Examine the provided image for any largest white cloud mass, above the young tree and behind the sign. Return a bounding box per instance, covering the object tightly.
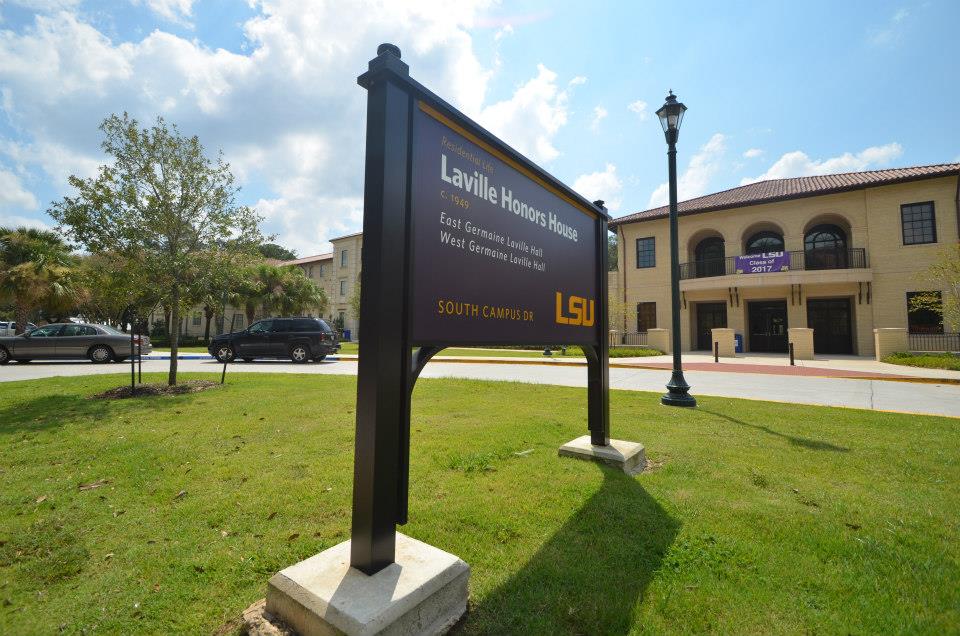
[0,0,586,253]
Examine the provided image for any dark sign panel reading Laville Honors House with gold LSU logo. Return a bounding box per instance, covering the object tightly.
[410,102,600,345]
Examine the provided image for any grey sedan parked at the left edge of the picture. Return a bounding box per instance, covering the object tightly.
[0,322,153,364]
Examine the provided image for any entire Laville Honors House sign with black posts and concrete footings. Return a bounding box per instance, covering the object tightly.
[258,44,645,633]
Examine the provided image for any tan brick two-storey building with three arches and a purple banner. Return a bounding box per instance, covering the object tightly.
[610,163,960,355]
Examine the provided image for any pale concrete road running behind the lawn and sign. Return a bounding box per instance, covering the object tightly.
[0,360,960,417]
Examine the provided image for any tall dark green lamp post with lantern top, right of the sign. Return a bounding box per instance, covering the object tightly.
[657,91,697,407]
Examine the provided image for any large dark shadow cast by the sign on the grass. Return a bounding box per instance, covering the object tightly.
[458,467,680,634]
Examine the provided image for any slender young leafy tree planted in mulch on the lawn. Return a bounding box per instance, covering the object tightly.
[49,113,263,385]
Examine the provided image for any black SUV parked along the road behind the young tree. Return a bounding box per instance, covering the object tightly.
[207,318,340,363]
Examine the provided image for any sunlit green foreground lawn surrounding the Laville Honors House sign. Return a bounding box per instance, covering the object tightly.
[0,373,960,635]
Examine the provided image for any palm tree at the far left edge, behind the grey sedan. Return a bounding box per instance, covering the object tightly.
[0,227,74,333]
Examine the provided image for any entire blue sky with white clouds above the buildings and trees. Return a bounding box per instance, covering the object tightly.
[0,0,960,256]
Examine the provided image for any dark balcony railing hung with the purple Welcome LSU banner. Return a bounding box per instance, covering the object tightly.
[680,247,868,280]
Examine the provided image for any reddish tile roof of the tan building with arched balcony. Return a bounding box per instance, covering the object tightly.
[610,163,960,229]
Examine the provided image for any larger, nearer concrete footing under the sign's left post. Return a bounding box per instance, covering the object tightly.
[266,532,470,636]
